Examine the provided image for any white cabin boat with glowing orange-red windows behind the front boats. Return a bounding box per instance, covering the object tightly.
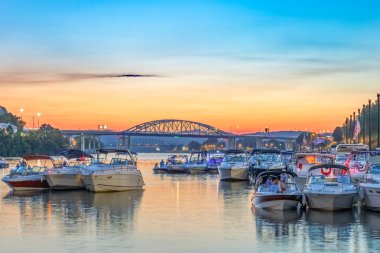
[291,153,335,186]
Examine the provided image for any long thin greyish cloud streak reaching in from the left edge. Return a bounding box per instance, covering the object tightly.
[0,73,160,85]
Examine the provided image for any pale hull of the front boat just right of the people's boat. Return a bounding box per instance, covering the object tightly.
[305,192,357,211]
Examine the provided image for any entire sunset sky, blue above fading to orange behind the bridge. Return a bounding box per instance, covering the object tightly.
[0,0,380,133]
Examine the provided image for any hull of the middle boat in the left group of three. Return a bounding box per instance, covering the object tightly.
[44,174,86,190]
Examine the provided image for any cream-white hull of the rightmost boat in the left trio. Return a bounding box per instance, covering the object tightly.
[83,171,144,192]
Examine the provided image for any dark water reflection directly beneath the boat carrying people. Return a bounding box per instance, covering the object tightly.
[252,208,302,223]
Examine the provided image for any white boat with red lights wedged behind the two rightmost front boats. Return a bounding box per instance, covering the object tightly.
[344,150,380,183]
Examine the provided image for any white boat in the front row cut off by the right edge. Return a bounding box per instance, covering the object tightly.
[359,156,380,211]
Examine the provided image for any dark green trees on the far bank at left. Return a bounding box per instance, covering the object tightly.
[0,110,69,157]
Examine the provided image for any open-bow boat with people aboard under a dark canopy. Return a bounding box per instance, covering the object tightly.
[252,169,302,210]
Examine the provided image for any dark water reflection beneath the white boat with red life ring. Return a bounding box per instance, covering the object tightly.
[305,209,355,226]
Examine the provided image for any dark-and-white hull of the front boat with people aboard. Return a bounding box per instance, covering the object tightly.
[252,194,302,210]
